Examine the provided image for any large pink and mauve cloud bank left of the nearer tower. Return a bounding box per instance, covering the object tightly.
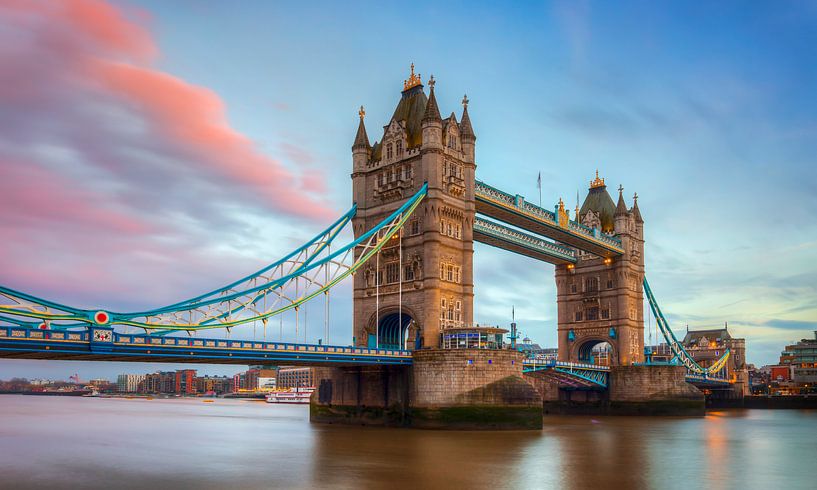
[0,0,337,308]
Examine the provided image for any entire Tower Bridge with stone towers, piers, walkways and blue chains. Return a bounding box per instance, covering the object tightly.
[0,65,744,427]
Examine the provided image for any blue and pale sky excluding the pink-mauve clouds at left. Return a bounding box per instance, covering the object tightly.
[0,1,817,378]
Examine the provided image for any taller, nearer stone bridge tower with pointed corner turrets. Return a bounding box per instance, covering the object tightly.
[352,64,476,349]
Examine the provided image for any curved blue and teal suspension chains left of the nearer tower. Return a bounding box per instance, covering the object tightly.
[0,184,428,334]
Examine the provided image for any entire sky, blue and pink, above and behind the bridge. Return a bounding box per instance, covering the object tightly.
[0,0,817,379]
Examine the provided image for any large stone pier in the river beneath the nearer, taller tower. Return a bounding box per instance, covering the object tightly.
[310,349,542,430]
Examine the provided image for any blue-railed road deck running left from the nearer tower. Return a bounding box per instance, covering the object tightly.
[0,327,411,366]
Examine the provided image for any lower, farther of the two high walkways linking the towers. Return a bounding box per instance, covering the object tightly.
[474,217,576,264]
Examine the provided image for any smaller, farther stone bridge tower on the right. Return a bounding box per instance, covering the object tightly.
[556,172,644,366]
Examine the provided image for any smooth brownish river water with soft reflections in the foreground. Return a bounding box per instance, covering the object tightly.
[0,395,817,489]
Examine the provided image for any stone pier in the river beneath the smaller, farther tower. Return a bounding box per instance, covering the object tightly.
[609,366,705,415]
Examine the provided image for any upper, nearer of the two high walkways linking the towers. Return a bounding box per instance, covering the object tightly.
[474,181,624,257]
